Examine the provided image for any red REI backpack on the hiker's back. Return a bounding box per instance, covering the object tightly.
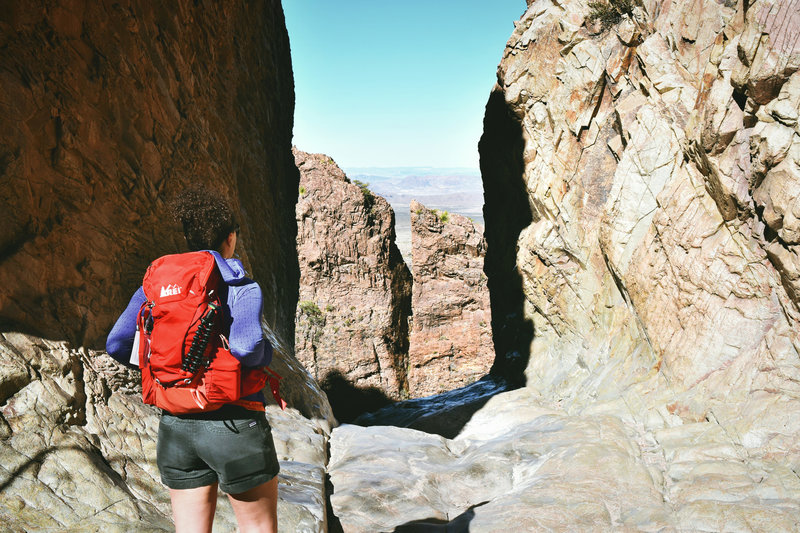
[137,252,285,414]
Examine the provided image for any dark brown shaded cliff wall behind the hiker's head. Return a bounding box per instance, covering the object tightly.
[0,1,299,347]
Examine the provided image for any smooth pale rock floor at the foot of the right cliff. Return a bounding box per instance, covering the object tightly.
[328,388,800,533]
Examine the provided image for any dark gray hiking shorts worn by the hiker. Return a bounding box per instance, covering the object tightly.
[156,406,280,494]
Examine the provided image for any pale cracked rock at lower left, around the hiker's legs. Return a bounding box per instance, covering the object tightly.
[0,332,335,532]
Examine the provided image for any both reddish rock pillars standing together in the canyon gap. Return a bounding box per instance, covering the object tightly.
[294,149,494,402]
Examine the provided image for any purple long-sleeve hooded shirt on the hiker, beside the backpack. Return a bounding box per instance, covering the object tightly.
[106,251,272,401]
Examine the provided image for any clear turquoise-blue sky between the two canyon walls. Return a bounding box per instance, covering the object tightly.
[283,0,526,170]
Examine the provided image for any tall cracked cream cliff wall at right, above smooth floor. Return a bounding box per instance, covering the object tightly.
[481,1,800,440]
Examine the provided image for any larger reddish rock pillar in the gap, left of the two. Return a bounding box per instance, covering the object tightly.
[294,149,411,402]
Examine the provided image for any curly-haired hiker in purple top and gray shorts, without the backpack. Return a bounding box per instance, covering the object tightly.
[106,187,279,533]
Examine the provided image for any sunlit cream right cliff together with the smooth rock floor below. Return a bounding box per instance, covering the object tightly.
[329,0,800,531]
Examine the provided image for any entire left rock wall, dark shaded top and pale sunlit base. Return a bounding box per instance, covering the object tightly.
[0,0,334,531]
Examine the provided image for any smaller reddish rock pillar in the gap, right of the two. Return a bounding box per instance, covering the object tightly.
[408,202,494,397]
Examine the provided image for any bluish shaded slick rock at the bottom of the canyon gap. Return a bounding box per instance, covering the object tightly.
[352,375,515,439]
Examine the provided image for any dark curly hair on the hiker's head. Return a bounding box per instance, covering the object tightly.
[172,186,239,251]
